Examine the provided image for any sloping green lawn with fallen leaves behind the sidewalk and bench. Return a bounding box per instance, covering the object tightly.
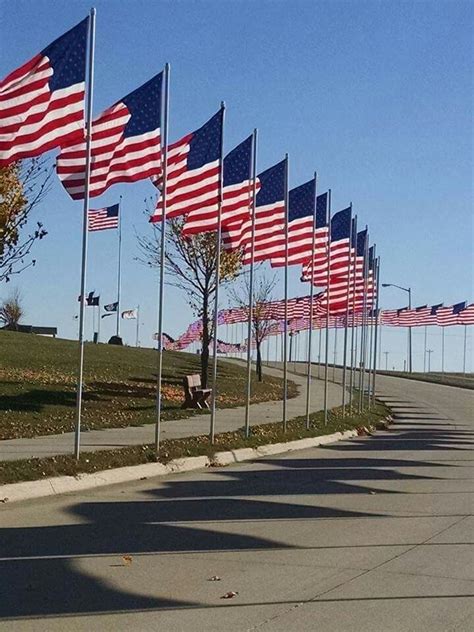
[0,331,297,439]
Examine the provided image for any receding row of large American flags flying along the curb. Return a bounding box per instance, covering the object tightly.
[0,18,374,326]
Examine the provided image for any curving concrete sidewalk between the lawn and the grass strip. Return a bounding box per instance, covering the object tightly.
[0,367,341,461]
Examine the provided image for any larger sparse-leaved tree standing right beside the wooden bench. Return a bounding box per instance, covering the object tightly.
[137,218,240,388]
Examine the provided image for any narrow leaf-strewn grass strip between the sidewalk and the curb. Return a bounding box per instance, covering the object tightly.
[0,401,390,486]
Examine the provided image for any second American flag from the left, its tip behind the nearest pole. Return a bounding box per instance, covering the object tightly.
[56,73,163,200]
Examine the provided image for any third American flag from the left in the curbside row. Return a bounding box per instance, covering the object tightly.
[150,108,224,222]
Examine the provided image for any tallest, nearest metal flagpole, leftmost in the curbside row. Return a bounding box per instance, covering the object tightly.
[74,9,96,459]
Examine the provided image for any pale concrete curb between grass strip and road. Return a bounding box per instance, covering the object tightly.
[0,422,386,504]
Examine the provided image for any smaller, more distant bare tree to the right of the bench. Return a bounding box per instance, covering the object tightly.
[231,268,276,382]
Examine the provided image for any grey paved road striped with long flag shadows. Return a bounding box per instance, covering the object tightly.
[0,377,474,632]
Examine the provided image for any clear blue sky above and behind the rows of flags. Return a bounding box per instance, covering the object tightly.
[0,0,473,370]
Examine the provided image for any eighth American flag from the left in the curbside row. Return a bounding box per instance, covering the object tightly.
[301,206,352,286]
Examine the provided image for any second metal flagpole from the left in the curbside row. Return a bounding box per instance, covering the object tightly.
[155,64,170,456]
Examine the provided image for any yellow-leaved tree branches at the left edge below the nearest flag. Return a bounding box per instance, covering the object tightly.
[0,157,53,282]
